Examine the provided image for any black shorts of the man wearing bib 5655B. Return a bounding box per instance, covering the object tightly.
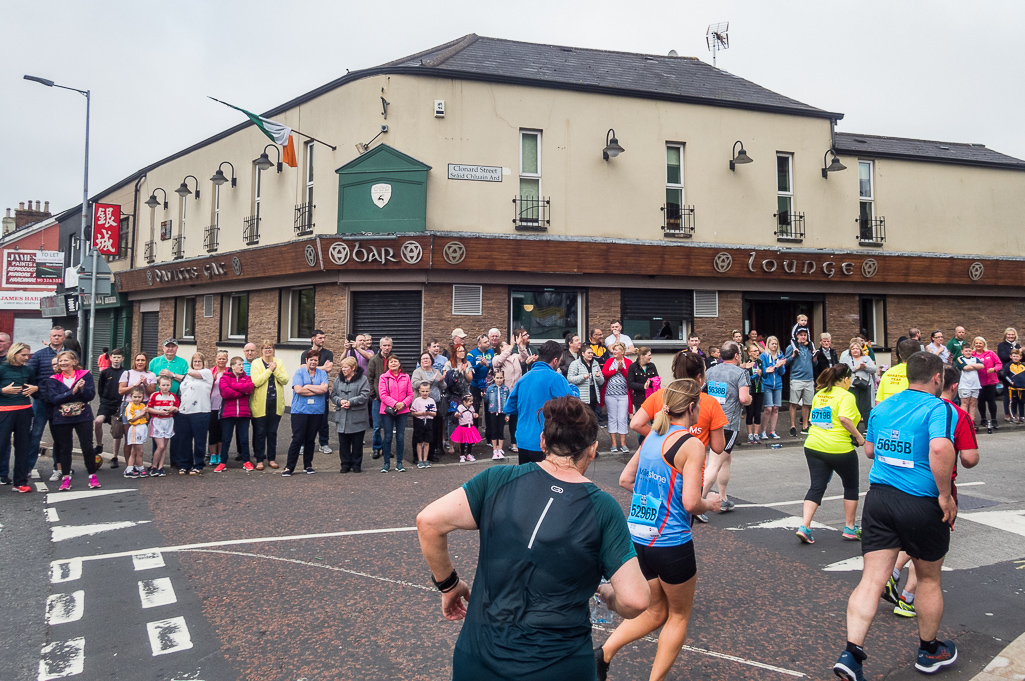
[861,483,950,562]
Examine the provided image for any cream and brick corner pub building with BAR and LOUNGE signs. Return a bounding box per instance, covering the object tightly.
[94,35,1025,373]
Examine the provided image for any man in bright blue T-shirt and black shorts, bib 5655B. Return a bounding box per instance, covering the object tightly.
[832,352,957,681]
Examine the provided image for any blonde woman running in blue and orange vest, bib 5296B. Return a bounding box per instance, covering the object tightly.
[595,378,722,681]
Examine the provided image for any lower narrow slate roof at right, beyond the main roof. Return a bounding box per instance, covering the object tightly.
[834,132,1025,170]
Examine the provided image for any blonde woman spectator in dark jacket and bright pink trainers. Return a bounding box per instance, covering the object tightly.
[44,350,99,491]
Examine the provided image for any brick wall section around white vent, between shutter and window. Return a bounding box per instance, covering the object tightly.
[422,284,511,348]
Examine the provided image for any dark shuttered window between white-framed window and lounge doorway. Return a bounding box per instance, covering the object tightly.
[620,288,694,345]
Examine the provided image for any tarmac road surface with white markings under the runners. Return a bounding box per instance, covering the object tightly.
[0,416,1025,681]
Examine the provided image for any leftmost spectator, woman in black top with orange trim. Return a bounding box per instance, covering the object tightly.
[0,343,39,493]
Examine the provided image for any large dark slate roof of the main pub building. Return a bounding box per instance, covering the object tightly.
[385,33,844,119]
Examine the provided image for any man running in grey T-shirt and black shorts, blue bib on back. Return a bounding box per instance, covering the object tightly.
[701,341,751,513]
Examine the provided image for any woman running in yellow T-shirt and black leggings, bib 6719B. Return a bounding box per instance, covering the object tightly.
[797,364,865,544]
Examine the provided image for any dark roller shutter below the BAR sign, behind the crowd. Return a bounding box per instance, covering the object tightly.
[348,291,423,373]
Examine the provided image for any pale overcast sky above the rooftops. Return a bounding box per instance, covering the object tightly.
[0,0,1025,218]
